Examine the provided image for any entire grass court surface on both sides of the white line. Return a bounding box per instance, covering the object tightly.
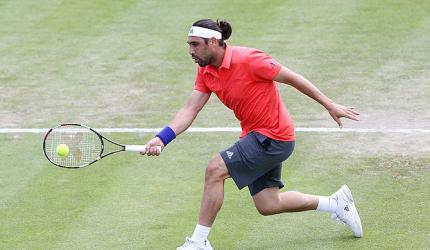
[0,0,430,249]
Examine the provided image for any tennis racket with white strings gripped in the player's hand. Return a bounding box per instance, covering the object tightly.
[43,123,161,168]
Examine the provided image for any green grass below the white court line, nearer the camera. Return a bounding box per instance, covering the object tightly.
[0,133,430,249]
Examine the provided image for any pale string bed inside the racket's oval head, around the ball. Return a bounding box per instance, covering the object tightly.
[45,125,103,168]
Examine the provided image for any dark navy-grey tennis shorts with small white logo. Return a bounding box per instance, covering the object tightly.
[220,132,294,195]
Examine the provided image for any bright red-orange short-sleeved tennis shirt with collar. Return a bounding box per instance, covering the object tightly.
[194,46,295,141]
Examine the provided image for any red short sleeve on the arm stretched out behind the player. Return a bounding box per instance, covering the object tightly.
[248,50,282,81]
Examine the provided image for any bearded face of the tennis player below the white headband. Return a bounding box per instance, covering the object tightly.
[187,36,213,67]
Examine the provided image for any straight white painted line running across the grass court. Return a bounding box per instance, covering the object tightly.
[0,127,430,134]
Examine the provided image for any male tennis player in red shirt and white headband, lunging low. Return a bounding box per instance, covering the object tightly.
[146,19,363,249]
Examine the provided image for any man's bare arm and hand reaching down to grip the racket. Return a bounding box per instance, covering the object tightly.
[146,90,210,155]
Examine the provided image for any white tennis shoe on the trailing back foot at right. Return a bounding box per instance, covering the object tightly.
[331,185,363,238]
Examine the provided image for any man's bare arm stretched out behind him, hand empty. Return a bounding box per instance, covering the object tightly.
[274,67,360,128]
